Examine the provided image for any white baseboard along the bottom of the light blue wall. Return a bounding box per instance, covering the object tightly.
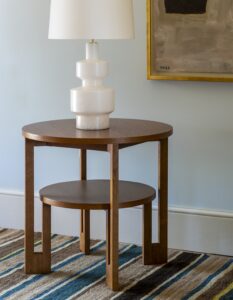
[0,191,233,256]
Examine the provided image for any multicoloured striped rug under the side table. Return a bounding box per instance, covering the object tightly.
[0,229,233,300]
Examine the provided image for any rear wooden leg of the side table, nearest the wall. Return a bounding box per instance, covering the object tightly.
[80,149,90,255]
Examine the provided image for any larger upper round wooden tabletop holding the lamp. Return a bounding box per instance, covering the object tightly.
[23,119,173,145]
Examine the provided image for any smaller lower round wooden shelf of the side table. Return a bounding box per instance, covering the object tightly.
[40,180,156,209]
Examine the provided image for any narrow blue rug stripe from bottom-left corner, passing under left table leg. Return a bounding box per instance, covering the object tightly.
[2,241,105,299]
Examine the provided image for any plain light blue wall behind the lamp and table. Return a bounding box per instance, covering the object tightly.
[0,0,233,210]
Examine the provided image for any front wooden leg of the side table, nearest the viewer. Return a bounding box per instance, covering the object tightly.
[106,144,119,291]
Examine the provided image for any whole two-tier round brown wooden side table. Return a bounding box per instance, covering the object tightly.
[23,119,173,290]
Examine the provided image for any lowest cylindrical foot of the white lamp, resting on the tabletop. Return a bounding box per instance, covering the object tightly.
[76,115,109,130]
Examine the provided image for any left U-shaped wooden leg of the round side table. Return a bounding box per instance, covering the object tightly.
[25,139,51,274]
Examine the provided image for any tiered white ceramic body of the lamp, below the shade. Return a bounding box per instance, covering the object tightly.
[70,41,115,130]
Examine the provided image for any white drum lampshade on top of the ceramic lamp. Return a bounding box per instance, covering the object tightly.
[49,0,134,39]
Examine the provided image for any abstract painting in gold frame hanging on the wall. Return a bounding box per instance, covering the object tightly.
[147,0,233,82]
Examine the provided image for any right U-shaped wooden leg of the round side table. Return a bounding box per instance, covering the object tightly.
[143,139,168,265]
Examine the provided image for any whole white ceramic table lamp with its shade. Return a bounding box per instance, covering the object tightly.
[49,0,134,130]
